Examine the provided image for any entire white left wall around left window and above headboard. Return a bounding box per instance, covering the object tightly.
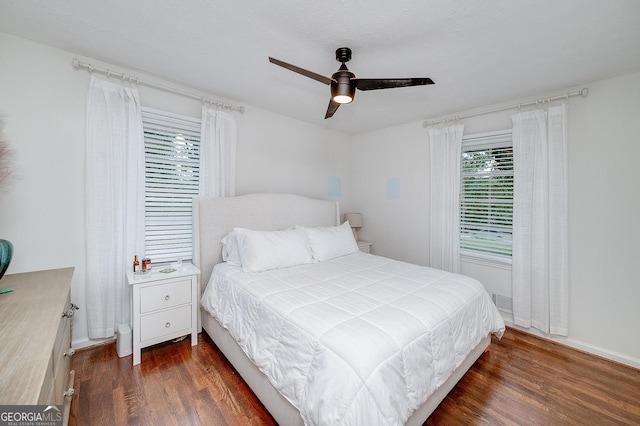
[0,32,351,346]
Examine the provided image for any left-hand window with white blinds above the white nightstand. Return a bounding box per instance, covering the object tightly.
[142,107,200,263]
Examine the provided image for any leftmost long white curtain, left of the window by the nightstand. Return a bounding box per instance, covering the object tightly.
[85,76,144,339]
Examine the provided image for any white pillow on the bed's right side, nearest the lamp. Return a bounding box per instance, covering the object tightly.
[302,221,359,261]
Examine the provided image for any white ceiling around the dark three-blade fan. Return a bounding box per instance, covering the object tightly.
[0,0,640,134]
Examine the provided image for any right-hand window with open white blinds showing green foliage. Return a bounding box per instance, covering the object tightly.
[460,130,513,261]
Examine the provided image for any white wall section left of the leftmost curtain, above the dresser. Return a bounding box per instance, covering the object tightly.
[0,33,87,348]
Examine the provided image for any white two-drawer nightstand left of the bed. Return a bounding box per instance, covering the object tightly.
[127,264,200,365]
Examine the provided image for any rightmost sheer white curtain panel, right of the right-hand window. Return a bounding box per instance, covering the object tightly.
[511,105,569,336]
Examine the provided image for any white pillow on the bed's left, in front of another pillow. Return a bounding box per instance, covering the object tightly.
[233,228,313,272]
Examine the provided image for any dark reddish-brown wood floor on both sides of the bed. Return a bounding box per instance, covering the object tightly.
[69,329,640,426]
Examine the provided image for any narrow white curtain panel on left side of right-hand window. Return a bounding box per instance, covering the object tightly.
[429,125,464,273]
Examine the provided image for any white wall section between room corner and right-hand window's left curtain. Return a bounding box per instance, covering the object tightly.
[351,123,430,265]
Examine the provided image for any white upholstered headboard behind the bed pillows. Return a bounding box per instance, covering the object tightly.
[193,194,340,290]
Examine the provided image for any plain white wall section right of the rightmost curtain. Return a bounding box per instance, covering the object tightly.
[569,73,640,366]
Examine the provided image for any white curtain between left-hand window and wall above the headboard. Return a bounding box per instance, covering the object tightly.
[199,105,236,197]
